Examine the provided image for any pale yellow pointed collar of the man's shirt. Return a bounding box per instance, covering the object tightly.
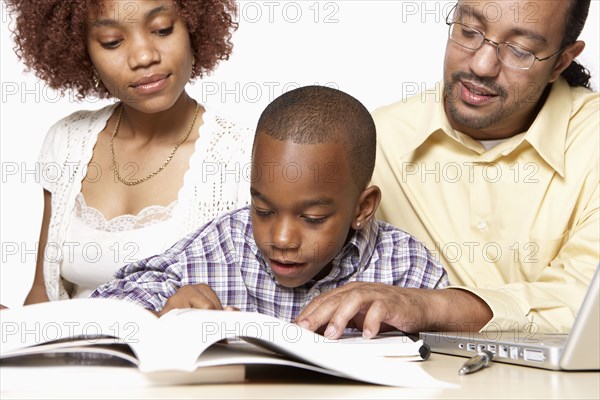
[405,78,573,176]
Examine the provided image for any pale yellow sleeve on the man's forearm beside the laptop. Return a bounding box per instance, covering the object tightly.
[457,187,600,333]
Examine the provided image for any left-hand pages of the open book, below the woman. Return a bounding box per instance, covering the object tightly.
[0,299,158,363]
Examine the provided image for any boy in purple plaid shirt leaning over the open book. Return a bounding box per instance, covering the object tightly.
[92,86,448,338]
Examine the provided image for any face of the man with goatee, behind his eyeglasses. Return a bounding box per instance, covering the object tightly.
[444,0,570,139]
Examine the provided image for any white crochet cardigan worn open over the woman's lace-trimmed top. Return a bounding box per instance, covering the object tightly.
[39,104,254,300]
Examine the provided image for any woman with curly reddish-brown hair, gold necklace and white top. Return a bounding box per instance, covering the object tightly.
[7,0,253,304]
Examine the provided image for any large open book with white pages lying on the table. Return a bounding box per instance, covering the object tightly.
[0,299,450,387]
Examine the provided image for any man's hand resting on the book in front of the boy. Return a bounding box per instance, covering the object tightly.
[294,282,492,339]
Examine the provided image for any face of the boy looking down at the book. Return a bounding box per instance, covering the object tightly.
[250,133,361,287]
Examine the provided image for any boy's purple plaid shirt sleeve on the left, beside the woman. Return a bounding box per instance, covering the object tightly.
[91,212,245,311]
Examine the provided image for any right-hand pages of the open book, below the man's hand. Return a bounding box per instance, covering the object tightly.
[148,309,446,387]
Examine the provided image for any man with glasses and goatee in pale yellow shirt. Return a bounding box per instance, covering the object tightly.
[297,0,600,333]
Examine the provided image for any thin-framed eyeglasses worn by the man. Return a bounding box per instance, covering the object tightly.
[446,9,564,70]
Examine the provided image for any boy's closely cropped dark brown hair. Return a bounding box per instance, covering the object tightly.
[256,86,377,189]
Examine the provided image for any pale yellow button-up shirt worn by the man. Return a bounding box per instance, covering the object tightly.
[373,79,600,332]
